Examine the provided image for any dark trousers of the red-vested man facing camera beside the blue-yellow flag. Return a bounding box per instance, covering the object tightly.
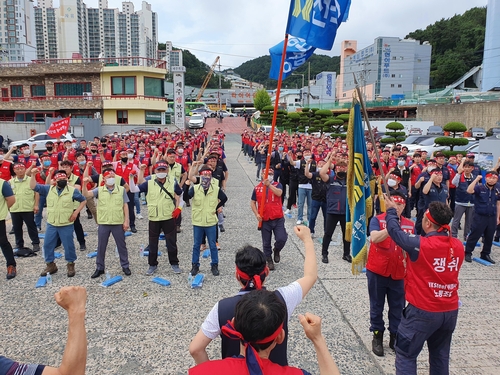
[366,270,405,334]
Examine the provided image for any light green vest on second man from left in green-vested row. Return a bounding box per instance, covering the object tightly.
[47,186,76,227]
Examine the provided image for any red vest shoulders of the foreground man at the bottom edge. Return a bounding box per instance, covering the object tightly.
[189,357,304,375]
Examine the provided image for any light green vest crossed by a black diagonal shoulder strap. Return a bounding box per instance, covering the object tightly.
[147,177,176,221]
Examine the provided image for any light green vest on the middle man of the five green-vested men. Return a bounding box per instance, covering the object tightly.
[97,185,125,225]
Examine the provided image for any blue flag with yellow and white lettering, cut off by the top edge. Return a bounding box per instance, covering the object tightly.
[286,0,351,50]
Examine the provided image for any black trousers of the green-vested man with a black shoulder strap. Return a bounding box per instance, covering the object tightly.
[148,219,179,266]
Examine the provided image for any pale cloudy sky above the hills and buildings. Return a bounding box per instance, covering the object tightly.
[84,0,488,69]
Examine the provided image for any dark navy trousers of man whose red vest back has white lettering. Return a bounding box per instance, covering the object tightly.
[395,304,458,375]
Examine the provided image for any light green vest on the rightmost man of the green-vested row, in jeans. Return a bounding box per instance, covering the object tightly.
[191,178,219,227]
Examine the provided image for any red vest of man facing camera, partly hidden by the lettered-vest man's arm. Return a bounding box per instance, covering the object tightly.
[366,213,415,280]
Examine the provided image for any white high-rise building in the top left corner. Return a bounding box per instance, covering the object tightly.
[0,0,36,62]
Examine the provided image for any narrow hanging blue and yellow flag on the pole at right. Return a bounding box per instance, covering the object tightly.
[346,103,373,275]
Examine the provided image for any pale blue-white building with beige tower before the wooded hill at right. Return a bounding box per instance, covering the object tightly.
[337,37,432,102]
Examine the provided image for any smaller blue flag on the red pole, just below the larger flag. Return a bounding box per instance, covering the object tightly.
[269,36,315,80]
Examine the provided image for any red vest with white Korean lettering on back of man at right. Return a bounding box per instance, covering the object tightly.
[405,235,465,312]
